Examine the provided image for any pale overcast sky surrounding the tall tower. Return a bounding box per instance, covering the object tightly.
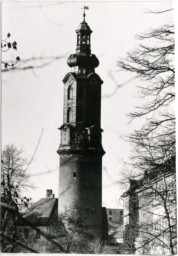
[2,1,172,207]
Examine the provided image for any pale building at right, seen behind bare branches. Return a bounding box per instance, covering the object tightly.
[122,158,177,255]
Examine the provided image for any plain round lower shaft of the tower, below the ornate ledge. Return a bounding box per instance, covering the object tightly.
[59,154,102,237]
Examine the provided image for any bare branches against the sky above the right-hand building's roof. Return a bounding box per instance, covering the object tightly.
[118,25,175,169]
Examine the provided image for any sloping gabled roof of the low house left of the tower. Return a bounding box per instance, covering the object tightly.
[23,198,58,226]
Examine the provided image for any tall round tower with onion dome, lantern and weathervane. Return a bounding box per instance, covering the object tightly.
[57,10,104,237]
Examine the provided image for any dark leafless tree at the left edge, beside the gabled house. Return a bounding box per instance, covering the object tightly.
[1,145,31,252]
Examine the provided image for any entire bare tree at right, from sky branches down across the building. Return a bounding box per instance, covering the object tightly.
[118,10,176,254]
